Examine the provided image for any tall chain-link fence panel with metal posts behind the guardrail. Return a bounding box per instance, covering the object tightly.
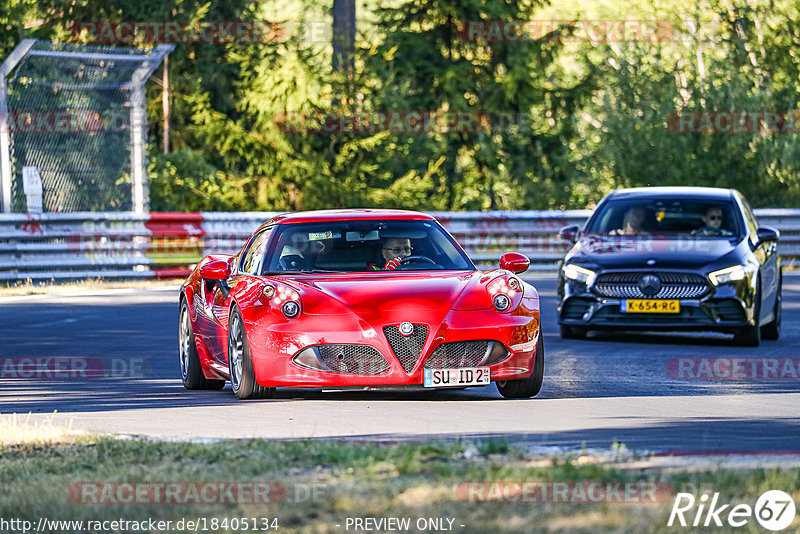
[0,40,172,212]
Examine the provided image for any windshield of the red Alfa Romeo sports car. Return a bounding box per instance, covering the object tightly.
[262,220,475,274]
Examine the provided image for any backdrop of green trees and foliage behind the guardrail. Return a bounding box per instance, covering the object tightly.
[0,0,800,210]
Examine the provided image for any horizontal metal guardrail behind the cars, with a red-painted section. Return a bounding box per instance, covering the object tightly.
[0,209,800,282]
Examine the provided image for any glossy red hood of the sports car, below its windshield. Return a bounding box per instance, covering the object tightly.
[289,271,490,322]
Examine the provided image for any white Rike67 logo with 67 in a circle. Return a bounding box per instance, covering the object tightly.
[667,490,796,532]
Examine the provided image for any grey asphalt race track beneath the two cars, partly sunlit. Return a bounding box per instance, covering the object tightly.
[0,276,800,453]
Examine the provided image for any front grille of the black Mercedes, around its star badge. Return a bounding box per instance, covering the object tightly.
[593,272,708,299]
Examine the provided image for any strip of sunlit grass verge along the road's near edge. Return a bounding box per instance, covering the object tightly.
[0,436,800,533]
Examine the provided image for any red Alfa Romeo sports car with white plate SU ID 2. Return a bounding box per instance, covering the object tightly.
[179,209,544,399]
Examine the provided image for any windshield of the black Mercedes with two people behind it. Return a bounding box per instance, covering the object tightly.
[586,198,741,238]
